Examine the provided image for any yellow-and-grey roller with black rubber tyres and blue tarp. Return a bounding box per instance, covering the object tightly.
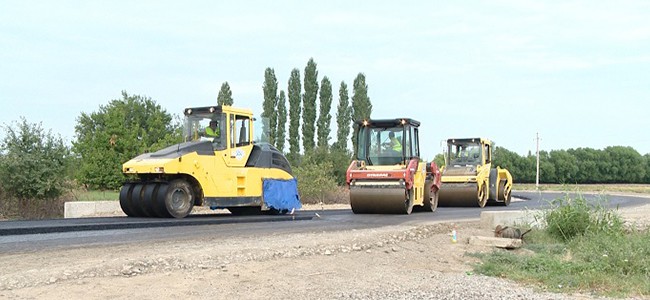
[119,105,301,218]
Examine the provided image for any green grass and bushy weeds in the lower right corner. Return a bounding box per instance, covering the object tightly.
[472,197,650,297]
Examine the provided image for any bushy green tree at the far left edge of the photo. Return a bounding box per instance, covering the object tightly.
[0,117,70,202]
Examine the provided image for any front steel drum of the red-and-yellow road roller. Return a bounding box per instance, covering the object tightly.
[350,185,412,214]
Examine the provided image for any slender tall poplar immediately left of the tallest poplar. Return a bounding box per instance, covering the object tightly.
[287,68,302,166]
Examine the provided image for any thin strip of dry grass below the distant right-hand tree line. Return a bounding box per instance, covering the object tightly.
[513,183,650,194]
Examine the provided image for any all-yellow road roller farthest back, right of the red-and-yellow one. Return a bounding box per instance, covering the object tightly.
[439,138,512,207]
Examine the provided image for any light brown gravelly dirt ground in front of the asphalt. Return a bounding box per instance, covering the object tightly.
[0,198,650,299]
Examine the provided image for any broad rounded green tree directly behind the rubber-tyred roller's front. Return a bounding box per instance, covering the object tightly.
[73,91,182,190]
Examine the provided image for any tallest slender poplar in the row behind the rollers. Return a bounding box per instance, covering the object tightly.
[302,58,318,153]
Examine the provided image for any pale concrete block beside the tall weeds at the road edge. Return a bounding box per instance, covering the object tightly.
[481,210,543,230]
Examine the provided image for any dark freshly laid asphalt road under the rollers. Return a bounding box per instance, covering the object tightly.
[0,191,647,253]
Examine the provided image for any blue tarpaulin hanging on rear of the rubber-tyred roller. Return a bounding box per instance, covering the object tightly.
[262,178,302,211]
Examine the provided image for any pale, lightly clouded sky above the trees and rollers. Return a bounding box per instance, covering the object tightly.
[0,0,650,159]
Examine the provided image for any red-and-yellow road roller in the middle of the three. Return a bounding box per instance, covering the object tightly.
[346,118,440,214]
